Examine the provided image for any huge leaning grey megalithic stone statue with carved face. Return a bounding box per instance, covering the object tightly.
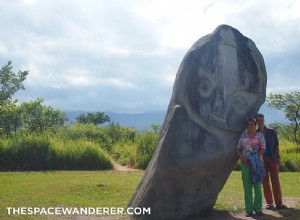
[128,25,267,220]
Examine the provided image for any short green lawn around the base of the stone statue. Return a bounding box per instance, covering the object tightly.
[0,171,300,219]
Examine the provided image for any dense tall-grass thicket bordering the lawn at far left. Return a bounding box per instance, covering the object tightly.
[0,134,112,171]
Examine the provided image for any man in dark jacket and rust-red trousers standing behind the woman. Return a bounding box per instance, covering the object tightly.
[256,114,287,209]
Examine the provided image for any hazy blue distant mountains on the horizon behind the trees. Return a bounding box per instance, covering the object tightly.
[67,104,287,130]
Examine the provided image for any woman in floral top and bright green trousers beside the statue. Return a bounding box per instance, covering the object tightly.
[237,118,266,217]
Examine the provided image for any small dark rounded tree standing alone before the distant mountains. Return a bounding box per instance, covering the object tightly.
[76,112,110,125]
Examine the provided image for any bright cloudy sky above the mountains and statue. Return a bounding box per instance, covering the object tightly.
[0,0,300,113]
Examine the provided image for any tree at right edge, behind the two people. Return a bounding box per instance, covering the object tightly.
[267,91,300,144]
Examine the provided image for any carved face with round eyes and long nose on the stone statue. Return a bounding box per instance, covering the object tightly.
[177,26,265,131]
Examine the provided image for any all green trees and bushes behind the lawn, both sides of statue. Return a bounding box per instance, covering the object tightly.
[0,61,300,171]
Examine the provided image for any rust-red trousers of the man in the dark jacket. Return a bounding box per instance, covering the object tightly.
[262,156,282,205]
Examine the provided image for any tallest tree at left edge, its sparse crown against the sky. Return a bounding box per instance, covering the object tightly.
[0,61,29,105]
